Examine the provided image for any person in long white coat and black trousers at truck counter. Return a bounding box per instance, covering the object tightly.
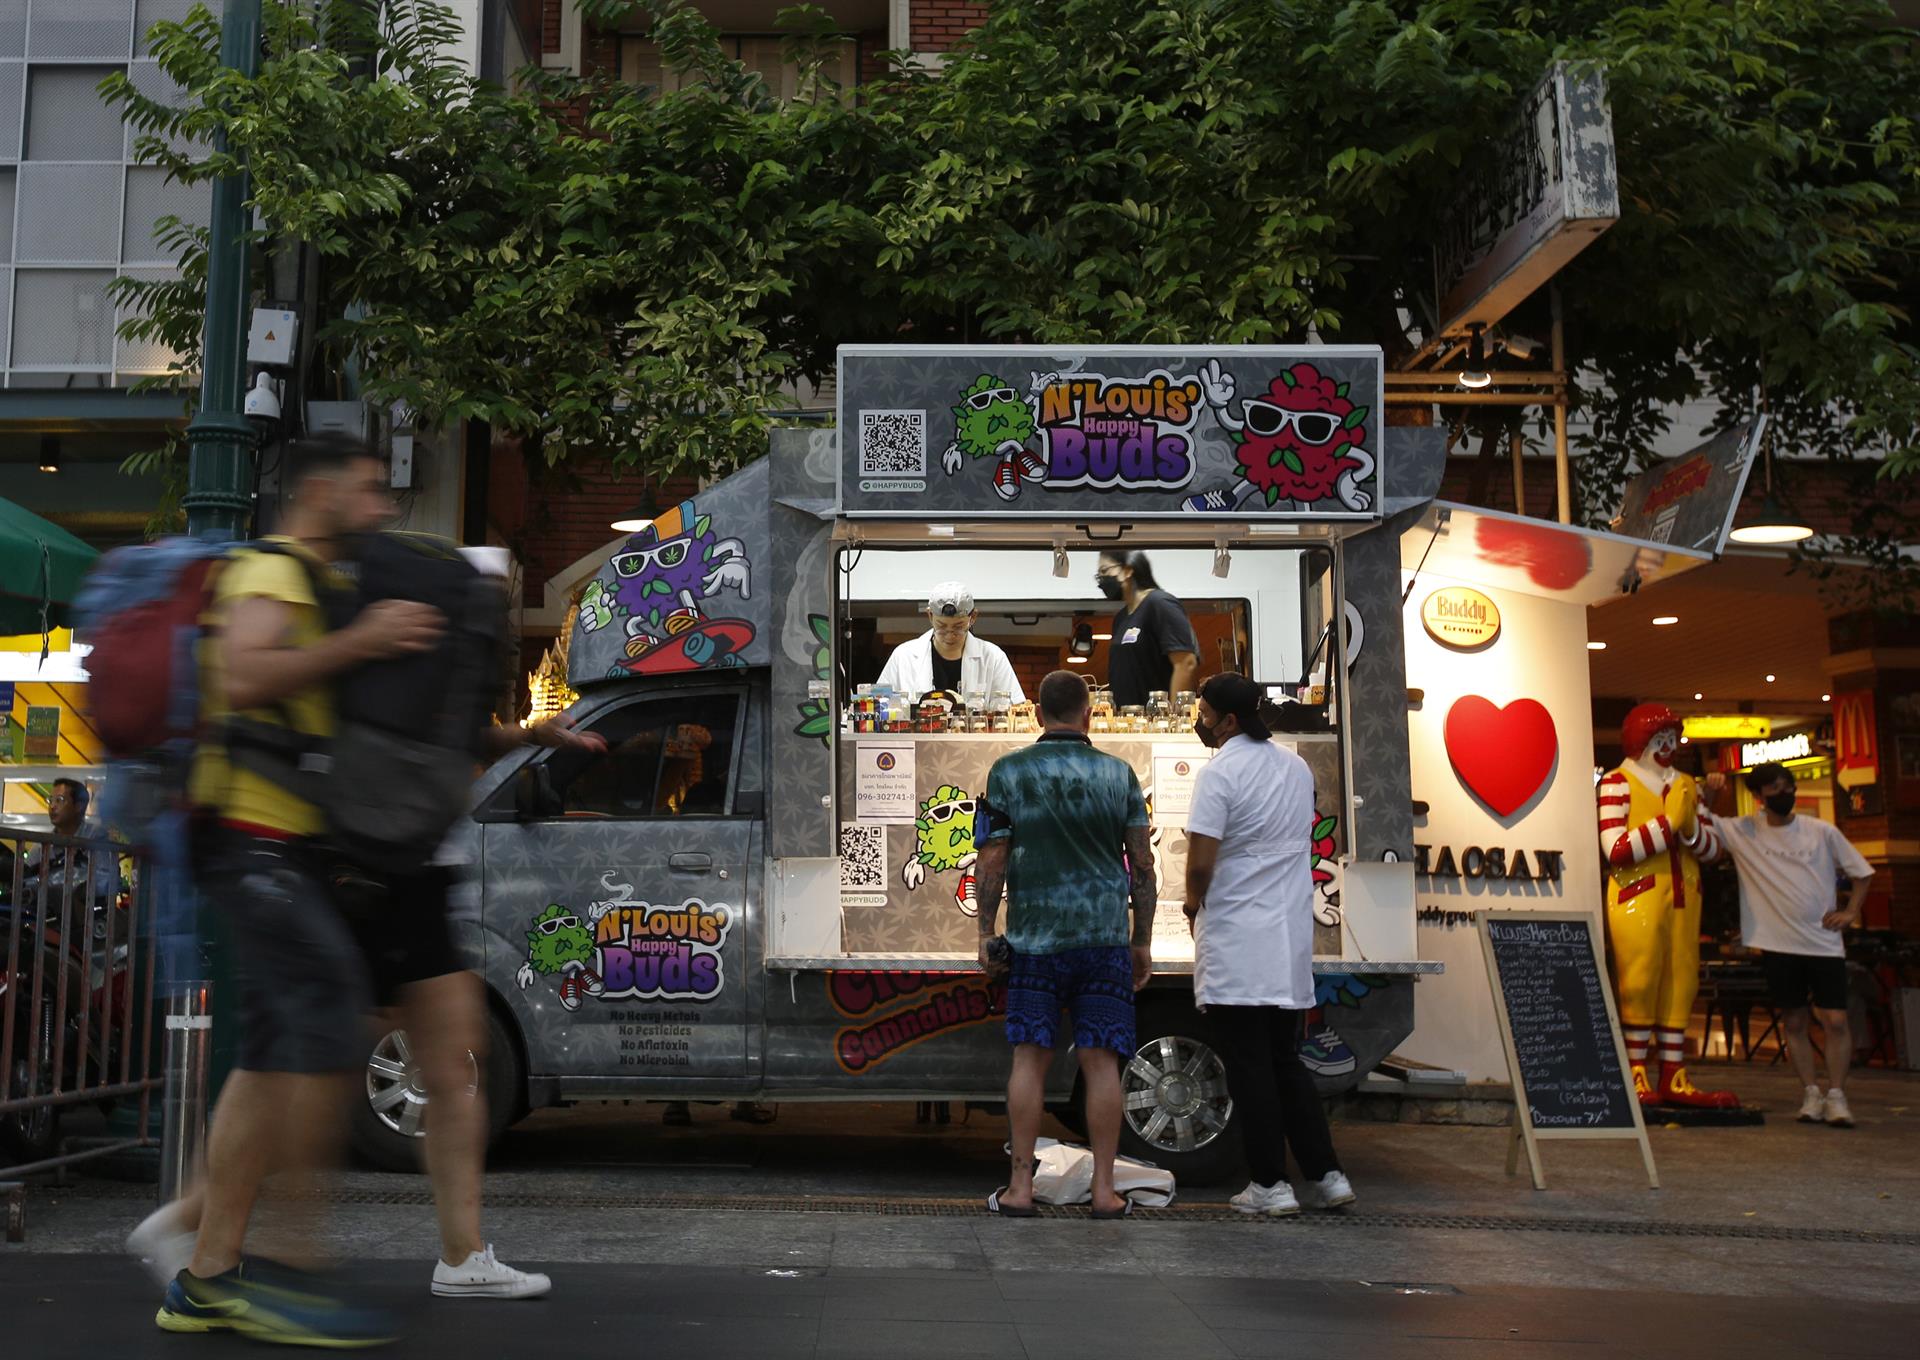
[1187,670,1354,1218]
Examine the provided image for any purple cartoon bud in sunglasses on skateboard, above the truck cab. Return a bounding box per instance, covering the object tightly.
[580,501,755,676]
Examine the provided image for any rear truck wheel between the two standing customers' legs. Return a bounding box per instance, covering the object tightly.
[1119,1003,1242,1185]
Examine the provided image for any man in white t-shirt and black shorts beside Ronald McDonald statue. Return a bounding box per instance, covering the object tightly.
[1707,763,1874,1128]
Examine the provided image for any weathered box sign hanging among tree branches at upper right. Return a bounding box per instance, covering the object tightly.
[1434,65,1620,334]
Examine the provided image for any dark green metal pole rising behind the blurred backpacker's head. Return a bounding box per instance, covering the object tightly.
[184,0,261,538]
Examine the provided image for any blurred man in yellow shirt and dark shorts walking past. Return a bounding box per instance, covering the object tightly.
[142,442,442,1347]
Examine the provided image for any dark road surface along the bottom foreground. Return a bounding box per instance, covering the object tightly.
[0,1252,1920,1360]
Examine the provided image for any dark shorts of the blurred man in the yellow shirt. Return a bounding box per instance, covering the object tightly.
[204,836,371,1074]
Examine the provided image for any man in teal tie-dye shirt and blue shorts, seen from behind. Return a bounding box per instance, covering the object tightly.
[975,670,1154,1218]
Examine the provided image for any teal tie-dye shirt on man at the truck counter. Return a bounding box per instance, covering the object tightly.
[985,732,1146,955]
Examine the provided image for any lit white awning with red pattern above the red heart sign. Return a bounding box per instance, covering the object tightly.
[1400,501,1713,605]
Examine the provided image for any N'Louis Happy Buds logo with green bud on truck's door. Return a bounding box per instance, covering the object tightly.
[515,874,735,1010]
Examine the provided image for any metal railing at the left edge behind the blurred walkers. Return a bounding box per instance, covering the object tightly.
[0,828,159,1198]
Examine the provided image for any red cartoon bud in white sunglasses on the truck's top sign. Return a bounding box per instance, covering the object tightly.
[1185,359,1373,515]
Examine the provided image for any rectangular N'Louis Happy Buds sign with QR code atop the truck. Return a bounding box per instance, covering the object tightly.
[839,346,1384,521]
